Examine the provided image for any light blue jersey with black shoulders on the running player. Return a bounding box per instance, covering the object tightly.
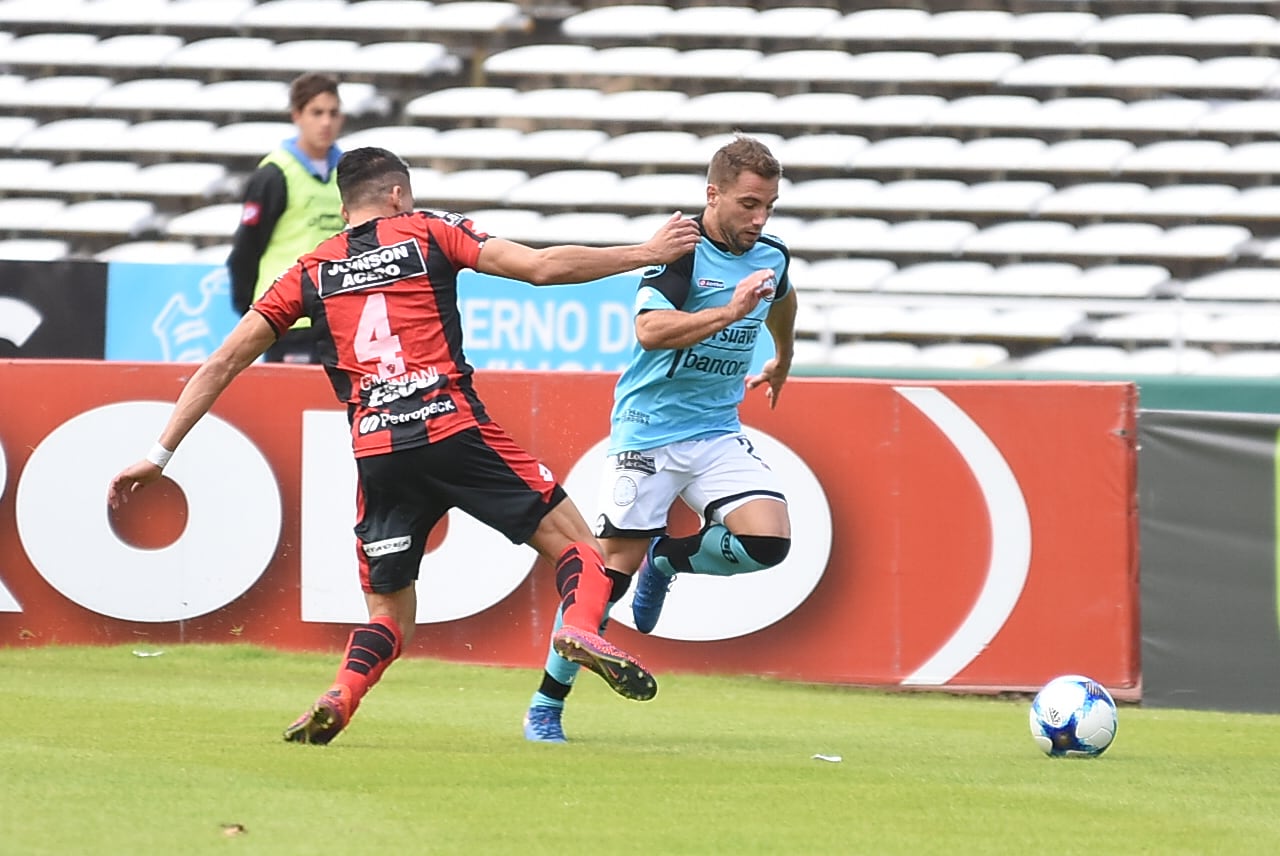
[609,217,791,454]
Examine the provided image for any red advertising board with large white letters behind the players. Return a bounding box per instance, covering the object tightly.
[0,361,1139,695]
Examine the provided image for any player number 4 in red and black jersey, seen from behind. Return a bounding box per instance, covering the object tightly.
[108,147,698,743]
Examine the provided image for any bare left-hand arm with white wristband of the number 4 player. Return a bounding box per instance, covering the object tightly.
[106,311,275,508]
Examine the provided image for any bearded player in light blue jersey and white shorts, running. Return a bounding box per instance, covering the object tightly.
[525,136,796,742]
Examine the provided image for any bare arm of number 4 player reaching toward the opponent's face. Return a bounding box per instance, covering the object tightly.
[476,211,701,285]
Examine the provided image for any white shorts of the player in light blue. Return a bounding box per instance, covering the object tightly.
[595,434,786,537]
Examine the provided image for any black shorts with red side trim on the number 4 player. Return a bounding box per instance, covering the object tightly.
[356,422,566,594]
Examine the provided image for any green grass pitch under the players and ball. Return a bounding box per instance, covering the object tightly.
[0,645,1280,856]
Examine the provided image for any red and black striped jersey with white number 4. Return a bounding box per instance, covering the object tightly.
[253,211,489,458]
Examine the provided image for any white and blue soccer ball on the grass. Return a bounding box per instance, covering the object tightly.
[1030,674,1116,757]
